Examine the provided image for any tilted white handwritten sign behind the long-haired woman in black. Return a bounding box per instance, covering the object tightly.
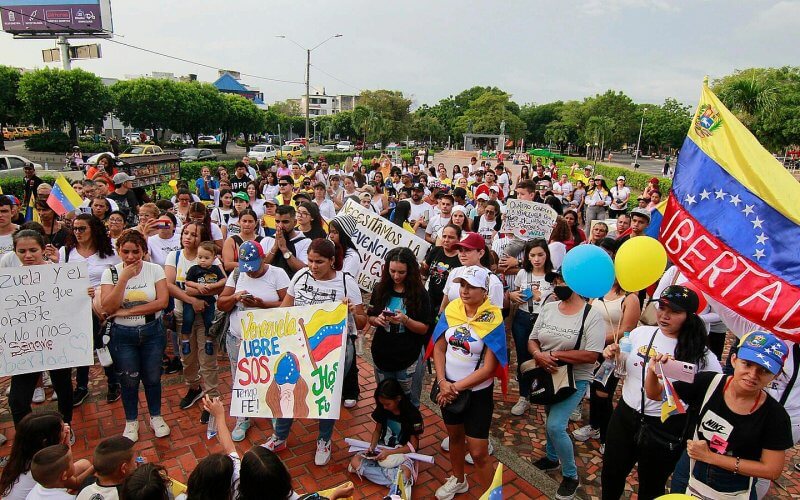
[339,200,430,292]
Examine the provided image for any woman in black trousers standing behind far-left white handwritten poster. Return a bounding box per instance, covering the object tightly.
[8,229,75,430]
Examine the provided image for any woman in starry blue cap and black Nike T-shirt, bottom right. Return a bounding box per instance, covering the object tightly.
[645,330,794,498]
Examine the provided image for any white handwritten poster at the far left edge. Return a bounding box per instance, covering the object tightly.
[0,263,94,375]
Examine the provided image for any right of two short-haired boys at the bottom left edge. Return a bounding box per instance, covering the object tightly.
[77,436,136,500]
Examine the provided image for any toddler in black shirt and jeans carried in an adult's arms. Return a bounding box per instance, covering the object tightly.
[181,241,225,356]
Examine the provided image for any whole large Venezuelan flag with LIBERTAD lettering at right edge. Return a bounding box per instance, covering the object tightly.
[659,80,800,342]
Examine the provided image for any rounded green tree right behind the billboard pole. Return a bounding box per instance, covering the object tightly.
[19,68,114,145]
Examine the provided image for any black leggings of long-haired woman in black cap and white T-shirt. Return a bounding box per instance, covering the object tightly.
[601,400,684,500]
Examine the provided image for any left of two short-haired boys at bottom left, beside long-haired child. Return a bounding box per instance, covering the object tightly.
[26,444,75,500]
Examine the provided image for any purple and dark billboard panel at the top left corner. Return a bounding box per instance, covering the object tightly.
[0,0,113,38]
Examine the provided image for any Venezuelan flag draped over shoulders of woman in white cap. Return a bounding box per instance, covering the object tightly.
[425,298,508,394]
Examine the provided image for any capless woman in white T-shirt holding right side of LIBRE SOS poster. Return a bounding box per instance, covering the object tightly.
[262,238,367,466]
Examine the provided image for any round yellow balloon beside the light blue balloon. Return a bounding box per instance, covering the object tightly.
[614,236,667,292]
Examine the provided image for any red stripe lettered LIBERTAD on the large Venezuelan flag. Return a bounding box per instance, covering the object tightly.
[659,194,800,342]
